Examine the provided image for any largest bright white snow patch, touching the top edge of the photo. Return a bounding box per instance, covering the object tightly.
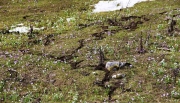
[93,0,153,13]
